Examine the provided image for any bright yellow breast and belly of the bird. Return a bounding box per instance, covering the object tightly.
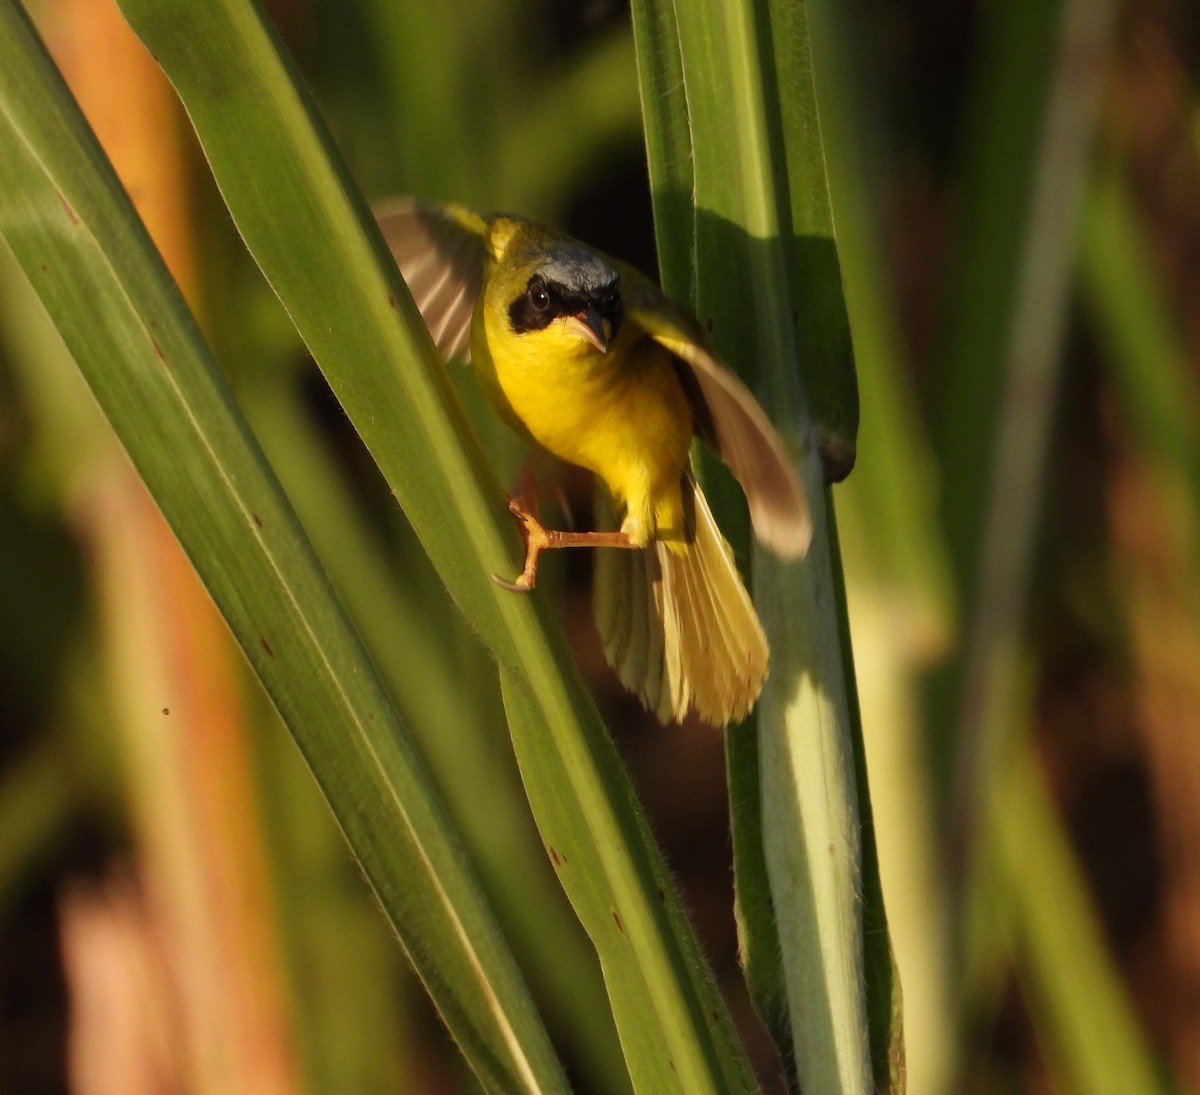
[472,312,691,544]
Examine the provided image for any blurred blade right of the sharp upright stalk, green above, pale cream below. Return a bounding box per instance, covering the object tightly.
[809,4,964,1093]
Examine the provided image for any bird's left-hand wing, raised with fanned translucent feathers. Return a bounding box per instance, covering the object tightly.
[376,198,487,360]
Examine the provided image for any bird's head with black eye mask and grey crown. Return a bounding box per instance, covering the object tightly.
[484,222,622,354]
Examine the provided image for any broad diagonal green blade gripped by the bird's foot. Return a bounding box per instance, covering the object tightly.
[112,0,754,1095]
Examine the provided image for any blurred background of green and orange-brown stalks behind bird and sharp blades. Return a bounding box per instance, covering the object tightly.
[0,0,1200,1095]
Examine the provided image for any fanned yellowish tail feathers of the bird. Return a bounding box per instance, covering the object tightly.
[594,475,768,726]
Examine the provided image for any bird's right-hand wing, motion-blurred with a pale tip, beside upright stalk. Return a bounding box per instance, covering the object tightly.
[620,264,812,558]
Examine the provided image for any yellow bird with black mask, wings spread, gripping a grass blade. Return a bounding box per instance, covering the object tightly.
[379,201,811,726]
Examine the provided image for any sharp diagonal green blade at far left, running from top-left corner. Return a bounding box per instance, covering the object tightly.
[0,0,566,1091]
